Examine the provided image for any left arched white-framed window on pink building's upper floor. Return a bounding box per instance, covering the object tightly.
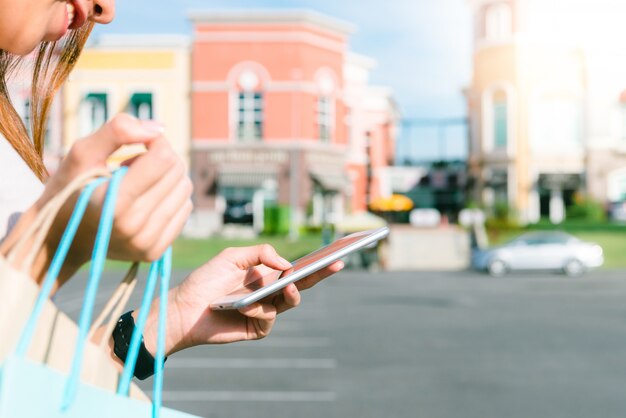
[237,70,263,142]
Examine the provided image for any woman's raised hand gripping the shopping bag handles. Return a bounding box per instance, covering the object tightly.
[5,114,192,285]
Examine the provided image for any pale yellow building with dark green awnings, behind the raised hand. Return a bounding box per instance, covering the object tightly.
[63,35,191,167]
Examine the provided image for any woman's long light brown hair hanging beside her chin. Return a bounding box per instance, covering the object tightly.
[0,22,93,181]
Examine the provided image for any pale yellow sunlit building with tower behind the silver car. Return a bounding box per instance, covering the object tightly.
[466,0,586,223]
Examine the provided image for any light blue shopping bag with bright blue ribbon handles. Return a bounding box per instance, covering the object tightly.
[0,169,197,418]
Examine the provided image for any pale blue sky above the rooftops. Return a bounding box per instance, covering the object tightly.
[96,0,471,160]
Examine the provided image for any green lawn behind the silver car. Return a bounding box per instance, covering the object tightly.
[489,229,626,269]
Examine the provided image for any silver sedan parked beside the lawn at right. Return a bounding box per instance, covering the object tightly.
[472,232,604,276]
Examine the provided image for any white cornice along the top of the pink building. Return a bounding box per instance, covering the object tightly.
[187,9,356,35]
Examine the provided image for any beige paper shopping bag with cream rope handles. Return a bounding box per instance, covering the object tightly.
[0,170,148,400]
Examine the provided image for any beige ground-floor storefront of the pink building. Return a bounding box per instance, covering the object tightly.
[191,144,351,231]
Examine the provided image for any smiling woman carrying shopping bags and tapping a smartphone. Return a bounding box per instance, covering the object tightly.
[0,0,343,376]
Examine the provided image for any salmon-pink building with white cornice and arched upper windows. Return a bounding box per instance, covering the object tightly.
[189,11,395,233]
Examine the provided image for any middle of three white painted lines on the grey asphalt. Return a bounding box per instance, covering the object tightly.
[167,358,337,369]
